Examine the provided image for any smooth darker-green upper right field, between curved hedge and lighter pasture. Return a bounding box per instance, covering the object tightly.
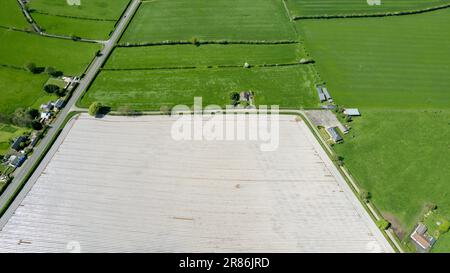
[297,9,450,109]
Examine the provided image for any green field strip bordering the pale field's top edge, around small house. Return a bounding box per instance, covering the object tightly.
[81,65,318,110]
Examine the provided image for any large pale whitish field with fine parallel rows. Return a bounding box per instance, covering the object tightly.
[0,115,392,252]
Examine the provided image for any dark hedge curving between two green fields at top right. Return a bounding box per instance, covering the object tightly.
[293,3,450,20]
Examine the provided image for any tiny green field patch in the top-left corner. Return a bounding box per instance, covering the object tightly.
[0,0,29,29]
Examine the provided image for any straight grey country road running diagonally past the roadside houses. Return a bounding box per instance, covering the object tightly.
[0,0,140,223]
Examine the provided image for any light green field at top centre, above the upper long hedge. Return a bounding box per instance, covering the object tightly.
[122,0,297,43]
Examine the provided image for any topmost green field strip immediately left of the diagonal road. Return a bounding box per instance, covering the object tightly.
[28,0,130,20]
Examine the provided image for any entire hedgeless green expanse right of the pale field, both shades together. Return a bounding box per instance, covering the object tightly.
[297,9,450,251]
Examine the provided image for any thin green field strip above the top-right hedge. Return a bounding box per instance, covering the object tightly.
[285,0,450,17]
